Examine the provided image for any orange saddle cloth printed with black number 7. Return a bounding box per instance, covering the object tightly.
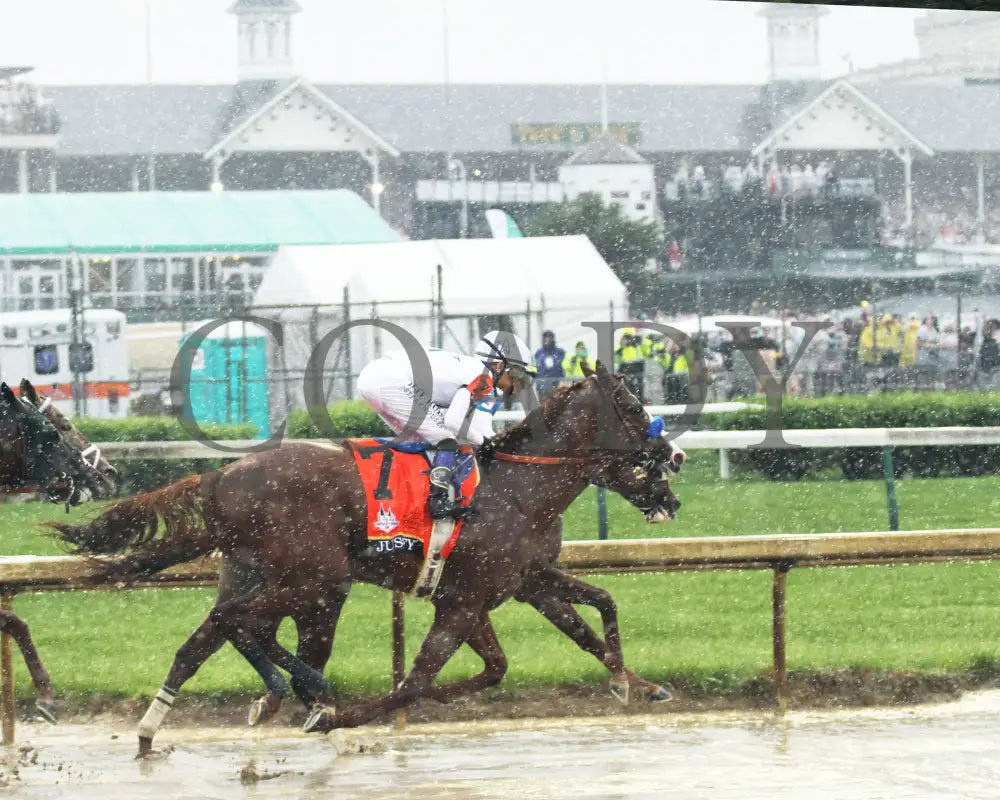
[346,439,479,558]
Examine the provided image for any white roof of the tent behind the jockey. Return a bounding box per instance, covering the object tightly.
[254,236,626,316]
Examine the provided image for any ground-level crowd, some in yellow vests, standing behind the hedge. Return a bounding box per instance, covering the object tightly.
[534,312,1000,405]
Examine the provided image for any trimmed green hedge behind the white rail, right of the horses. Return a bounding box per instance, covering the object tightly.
[702,392,1000,480]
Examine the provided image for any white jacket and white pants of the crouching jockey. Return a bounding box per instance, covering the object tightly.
[357,349,494,446]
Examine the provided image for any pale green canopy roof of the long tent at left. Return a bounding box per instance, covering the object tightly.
[0,189,400,256]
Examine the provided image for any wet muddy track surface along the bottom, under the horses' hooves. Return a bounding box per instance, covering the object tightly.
[0,692,1000,800]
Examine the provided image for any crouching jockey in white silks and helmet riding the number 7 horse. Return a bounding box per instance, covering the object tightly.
[357,331,536,519]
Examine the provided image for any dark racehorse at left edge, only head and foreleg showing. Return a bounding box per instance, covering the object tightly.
[0,381,114,722]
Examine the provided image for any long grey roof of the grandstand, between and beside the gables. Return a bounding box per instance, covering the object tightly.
[39,82,1000,156]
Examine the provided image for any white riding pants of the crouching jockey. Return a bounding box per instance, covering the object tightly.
[357,359,455,445]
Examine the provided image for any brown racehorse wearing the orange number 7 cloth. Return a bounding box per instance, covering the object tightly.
[53,366,679,744]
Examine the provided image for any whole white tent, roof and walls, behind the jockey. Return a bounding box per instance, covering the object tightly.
[252,236,628,422]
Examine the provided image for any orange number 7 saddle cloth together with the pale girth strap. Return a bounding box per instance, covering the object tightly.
[345,438,479,598]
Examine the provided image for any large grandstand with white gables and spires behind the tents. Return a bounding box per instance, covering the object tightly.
[0,0,1000,314]
